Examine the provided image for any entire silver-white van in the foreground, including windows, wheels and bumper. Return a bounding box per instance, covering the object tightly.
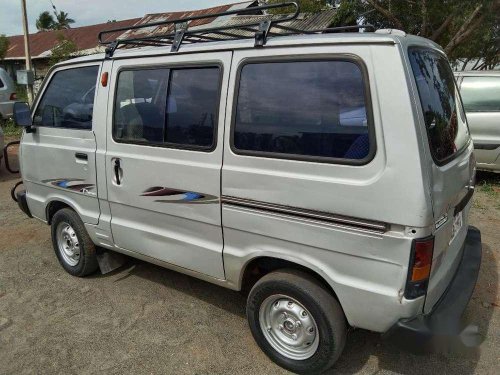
[8,4,481,373]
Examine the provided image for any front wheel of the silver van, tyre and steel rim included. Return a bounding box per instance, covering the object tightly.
[51,208,99,277]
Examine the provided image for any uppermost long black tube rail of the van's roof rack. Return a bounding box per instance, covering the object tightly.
[98,2,300,45]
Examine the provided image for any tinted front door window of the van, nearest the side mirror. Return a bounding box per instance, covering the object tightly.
[33,65,99,130]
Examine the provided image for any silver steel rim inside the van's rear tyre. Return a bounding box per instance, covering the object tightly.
[259,294,319,361]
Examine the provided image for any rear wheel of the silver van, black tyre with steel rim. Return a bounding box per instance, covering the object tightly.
[247,270,347,374]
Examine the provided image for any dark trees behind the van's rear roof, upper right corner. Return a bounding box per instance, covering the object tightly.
[333,0,500,68]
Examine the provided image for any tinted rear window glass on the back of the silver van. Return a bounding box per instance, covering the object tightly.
[409,48,470,164]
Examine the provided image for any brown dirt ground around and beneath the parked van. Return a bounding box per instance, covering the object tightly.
[0,142,500,375]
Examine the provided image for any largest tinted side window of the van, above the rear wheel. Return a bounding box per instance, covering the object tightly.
[233,60,374,161]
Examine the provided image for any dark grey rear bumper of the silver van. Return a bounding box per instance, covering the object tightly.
[384,227,482,346]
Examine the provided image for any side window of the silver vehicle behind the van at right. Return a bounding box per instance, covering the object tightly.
[460,77,500,112]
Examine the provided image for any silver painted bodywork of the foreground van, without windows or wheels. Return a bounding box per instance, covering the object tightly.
[17,31,473,332]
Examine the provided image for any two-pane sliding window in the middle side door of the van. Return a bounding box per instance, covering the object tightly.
[113,67,220,149]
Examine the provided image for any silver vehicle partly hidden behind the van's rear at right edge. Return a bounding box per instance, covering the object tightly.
[455,71,500,173]
